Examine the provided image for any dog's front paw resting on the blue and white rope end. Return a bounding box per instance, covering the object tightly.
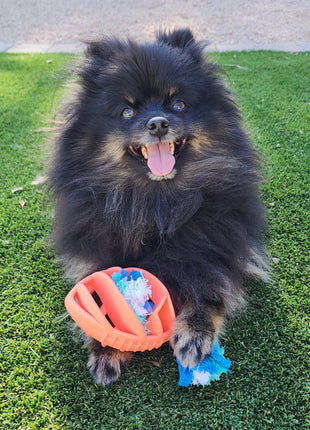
[170,308,223,368]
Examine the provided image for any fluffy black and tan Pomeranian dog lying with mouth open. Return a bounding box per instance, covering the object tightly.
[51,29,267,385]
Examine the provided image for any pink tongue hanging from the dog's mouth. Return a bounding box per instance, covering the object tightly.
[147,142,175,176]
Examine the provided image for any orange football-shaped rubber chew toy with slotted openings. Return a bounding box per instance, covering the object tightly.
[65,267,175,351]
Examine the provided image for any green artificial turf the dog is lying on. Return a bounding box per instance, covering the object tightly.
[0,52,310,430]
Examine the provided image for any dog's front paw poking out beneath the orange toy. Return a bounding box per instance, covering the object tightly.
[87,339,132,385]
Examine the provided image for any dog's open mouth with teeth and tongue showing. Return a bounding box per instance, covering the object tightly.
[128,138,187,177]
